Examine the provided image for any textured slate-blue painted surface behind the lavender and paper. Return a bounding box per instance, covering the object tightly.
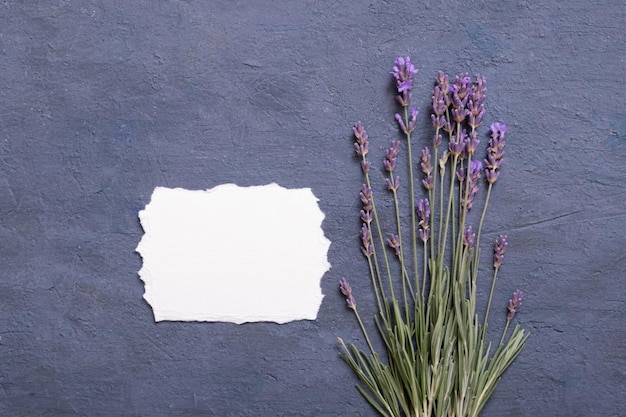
[0,0,626,417]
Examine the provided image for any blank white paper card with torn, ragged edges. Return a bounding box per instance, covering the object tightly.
[137,184,330,323]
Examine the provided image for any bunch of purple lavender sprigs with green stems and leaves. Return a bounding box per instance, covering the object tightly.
[339,57,528,417]
